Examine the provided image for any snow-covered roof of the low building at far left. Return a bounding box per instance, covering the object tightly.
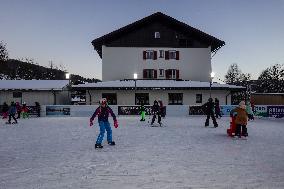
[0,80,69,90]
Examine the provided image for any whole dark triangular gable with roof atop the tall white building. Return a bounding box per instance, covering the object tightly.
[92,12,225,57]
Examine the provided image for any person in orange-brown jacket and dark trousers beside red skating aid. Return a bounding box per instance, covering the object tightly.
[230,101,248,138]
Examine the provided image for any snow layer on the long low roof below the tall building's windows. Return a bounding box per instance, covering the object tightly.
[72,80,244,89]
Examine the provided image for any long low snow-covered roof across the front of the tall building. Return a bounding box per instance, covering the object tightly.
[72,80,245,90]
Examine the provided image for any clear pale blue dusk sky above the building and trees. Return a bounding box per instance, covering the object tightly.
[0,0,284,81]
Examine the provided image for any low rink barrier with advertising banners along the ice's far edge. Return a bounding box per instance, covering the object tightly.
[41,105,284,118]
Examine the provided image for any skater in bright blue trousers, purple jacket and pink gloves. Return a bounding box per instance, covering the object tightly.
[90,98,118,148]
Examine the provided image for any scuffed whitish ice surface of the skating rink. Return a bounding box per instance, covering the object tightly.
[0,117,284,189]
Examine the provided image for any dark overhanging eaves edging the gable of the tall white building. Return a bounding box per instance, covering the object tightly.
[92,12,225,57]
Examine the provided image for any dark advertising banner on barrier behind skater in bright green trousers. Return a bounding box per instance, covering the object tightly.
[118,106,166,115]
